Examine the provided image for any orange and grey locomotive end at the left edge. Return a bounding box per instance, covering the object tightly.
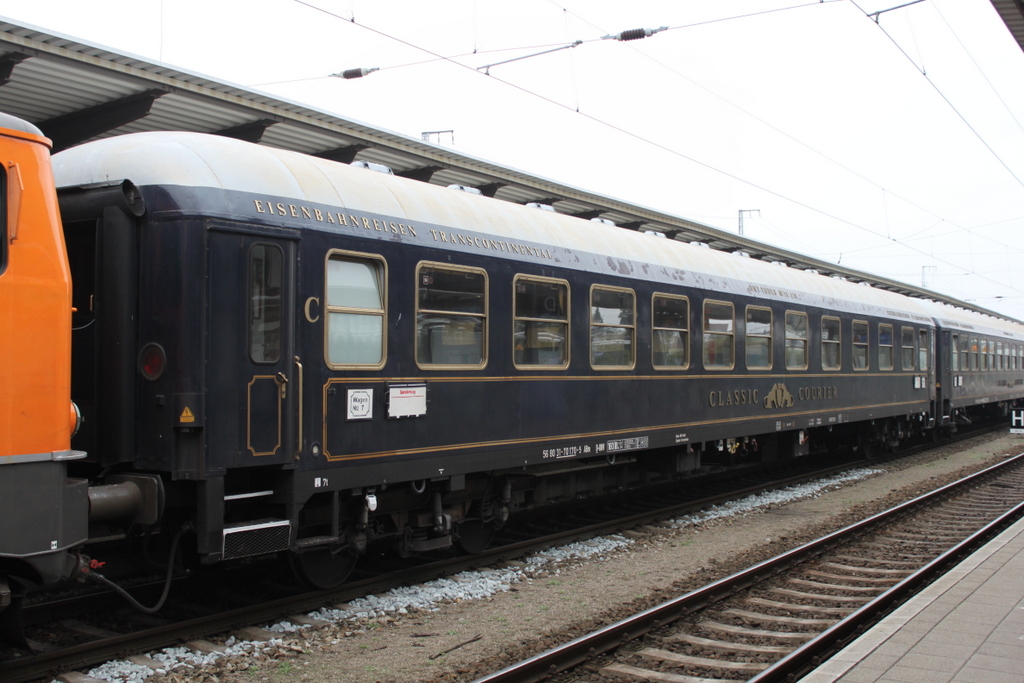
[0,114,89,611]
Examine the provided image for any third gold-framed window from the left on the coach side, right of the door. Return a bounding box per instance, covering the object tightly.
[512,275,569,368]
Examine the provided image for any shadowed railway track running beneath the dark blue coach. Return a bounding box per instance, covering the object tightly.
[0,430,1007,683]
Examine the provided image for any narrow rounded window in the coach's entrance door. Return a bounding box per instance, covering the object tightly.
[249,245,285,364]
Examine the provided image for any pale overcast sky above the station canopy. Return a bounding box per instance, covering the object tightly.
[0,0,1024,319]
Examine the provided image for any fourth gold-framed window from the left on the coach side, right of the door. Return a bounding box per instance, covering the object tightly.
[590,287,636,370]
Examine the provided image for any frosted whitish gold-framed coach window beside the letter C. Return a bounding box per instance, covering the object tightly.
[325,252,387,368]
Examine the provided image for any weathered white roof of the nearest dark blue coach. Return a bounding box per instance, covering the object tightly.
[53,132,935,323]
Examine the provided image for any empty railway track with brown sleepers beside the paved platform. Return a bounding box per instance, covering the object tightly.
[475,454,1024,683]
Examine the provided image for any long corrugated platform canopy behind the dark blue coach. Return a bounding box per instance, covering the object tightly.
[0,14,1022,325]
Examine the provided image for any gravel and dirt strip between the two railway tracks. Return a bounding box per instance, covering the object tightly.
[74,435,1024,683]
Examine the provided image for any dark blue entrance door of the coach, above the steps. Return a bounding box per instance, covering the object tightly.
[207,226,301,468]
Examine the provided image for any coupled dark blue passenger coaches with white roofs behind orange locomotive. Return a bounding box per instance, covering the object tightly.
[54,133,1024,586]
